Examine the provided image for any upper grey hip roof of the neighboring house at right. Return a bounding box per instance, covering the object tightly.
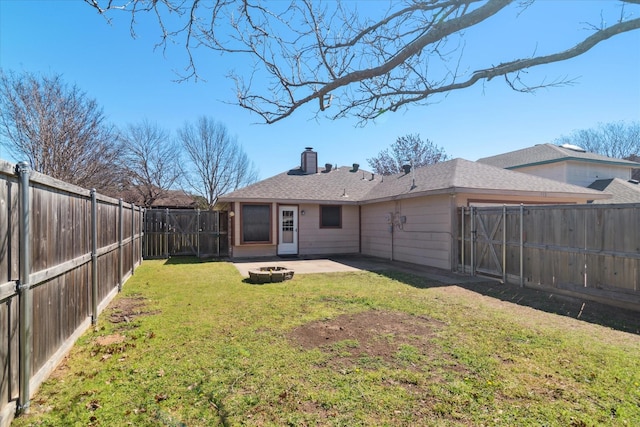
[478,144,640,169]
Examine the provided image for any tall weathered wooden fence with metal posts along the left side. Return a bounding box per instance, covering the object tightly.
[0,160,143,426]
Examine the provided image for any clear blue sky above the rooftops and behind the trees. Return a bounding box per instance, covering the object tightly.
[0,0,640,178]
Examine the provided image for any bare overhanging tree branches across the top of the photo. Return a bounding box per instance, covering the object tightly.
[85,0,640,123]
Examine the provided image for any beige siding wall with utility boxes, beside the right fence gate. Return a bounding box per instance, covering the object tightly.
[362,195,453,270]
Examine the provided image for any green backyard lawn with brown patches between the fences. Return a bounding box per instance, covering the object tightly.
[13,259,640,427]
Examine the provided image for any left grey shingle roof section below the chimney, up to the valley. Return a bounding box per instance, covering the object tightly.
[218,166,379,204]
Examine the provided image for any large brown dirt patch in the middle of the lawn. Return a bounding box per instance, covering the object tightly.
[290,310,452,367]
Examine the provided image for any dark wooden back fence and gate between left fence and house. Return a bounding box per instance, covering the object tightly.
[143,209,229,259]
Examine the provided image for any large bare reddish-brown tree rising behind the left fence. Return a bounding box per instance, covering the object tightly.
[0,70,125,195]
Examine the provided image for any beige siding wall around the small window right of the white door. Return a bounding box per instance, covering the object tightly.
[298,204,360,255]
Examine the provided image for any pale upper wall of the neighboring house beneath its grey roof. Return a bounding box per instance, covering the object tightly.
[513,161,632,187]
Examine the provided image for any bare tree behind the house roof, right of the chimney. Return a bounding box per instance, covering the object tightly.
[367,134,447,175]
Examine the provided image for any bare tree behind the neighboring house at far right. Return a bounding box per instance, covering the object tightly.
[554,121,640,179]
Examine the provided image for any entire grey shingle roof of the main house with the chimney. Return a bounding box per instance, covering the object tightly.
[219,159,610,204]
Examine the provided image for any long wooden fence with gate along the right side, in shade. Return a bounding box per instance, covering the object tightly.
[458,203,640,310]
